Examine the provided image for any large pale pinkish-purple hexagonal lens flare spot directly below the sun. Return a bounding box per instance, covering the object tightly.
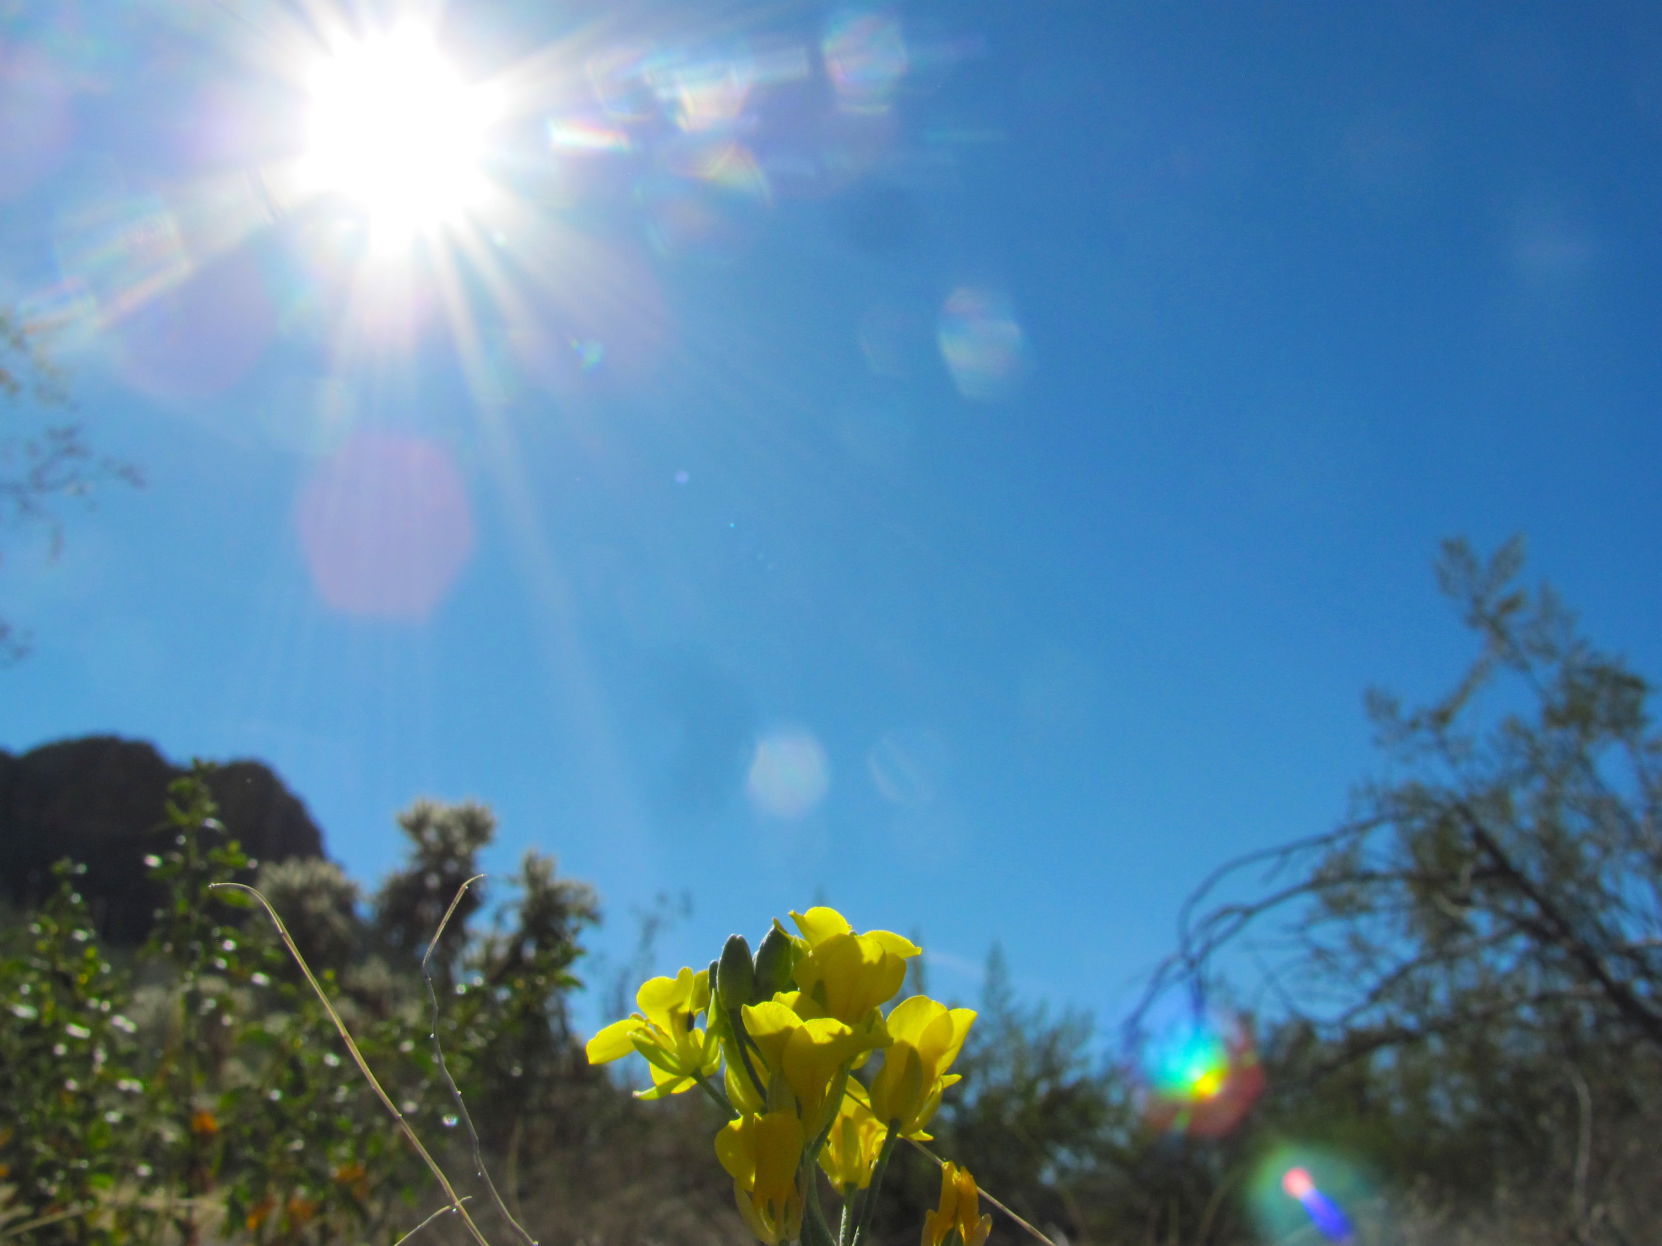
[297,434,474,621]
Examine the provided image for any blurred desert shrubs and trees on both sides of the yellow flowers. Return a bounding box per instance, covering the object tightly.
[0,545,1662,1246]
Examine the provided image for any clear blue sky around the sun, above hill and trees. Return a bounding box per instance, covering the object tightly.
[0,0,1662,1043]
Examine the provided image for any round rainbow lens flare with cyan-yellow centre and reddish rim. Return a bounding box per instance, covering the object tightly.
[1142,1018,1263,1138]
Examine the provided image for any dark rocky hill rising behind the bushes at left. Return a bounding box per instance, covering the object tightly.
[0,736,324,944]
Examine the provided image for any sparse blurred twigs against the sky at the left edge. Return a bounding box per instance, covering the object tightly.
[0,309,141,663]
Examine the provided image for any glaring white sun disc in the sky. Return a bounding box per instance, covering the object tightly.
[301,23,502,243]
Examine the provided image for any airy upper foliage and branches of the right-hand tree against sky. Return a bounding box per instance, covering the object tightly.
[1168,542,1662,1053]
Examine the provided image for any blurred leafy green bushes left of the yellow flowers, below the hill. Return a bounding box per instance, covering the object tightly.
[0,769,663,1246]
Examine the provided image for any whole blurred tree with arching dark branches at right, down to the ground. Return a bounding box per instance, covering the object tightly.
[1133,540,1662,1239]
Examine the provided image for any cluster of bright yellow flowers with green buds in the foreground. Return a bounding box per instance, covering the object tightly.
[588,907,987,1246]
